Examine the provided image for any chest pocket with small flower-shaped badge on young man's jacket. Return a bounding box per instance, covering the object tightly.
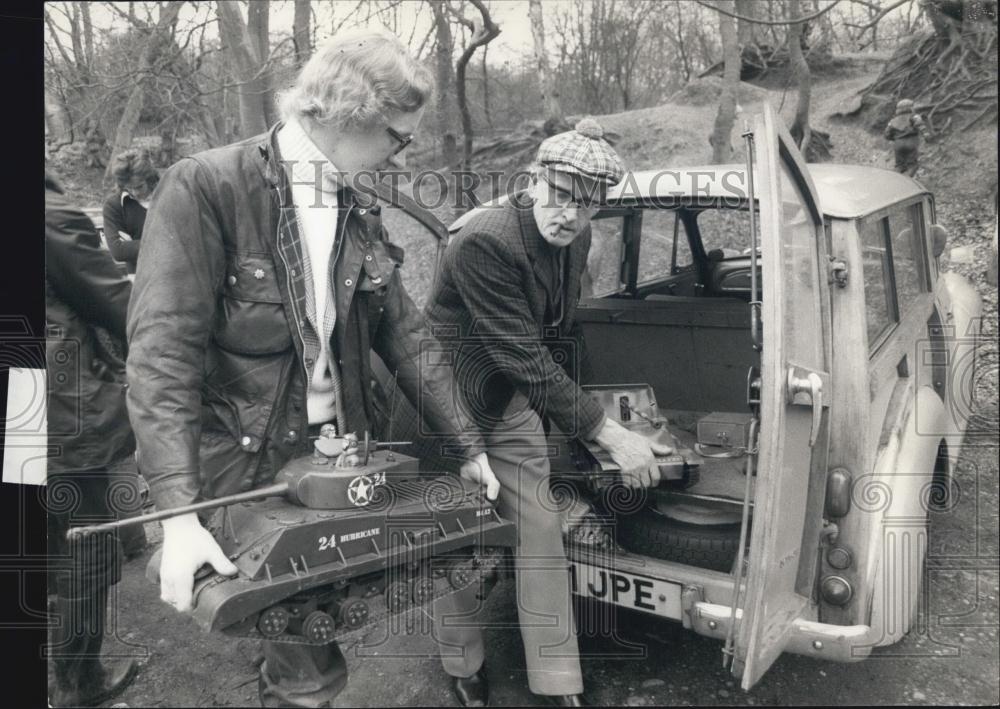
[215,253,292,355]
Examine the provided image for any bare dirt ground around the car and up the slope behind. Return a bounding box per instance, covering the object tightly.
[50,58,1000,707]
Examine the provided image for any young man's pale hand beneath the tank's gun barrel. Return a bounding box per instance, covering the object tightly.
[160,512,238,611]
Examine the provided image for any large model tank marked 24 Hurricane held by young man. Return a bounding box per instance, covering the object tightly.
[71,428,516,644]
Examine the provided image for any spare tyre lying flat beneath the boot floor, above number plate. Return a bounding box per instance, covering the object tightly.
[615,507,740,571]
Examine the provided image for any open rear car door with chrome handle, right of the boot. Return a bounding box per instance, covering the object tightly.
[732,104,831,690]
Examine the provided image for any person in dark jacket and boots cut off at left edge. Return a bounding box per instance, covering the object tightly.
[45,169,136,706]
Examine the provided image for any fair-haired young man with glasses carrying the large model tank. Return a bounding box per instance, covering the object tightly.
[128,31,499,707]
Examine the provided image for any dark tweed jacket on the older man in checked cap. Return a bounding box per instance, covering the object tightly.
[425,193,604,438]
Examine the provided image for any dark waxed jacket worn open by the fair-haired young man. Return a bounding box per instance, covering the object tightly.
[127,123,485,509]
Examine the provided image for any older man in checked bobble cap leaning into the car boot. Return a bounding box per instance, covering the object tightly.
[426,119,671,706]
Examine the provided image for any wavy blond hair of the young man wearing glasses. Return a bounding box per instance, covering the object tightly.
[278,30,434,128]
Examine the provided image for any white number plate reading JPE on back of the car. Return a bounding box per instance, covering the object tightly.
[569,561,681,620]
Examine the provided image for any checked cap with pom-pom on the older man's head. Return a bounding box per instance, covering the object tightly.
[537,118,625,186]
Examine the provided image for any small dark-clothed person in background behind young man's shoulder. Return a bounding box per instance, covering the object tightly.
[104,150,160,273]
